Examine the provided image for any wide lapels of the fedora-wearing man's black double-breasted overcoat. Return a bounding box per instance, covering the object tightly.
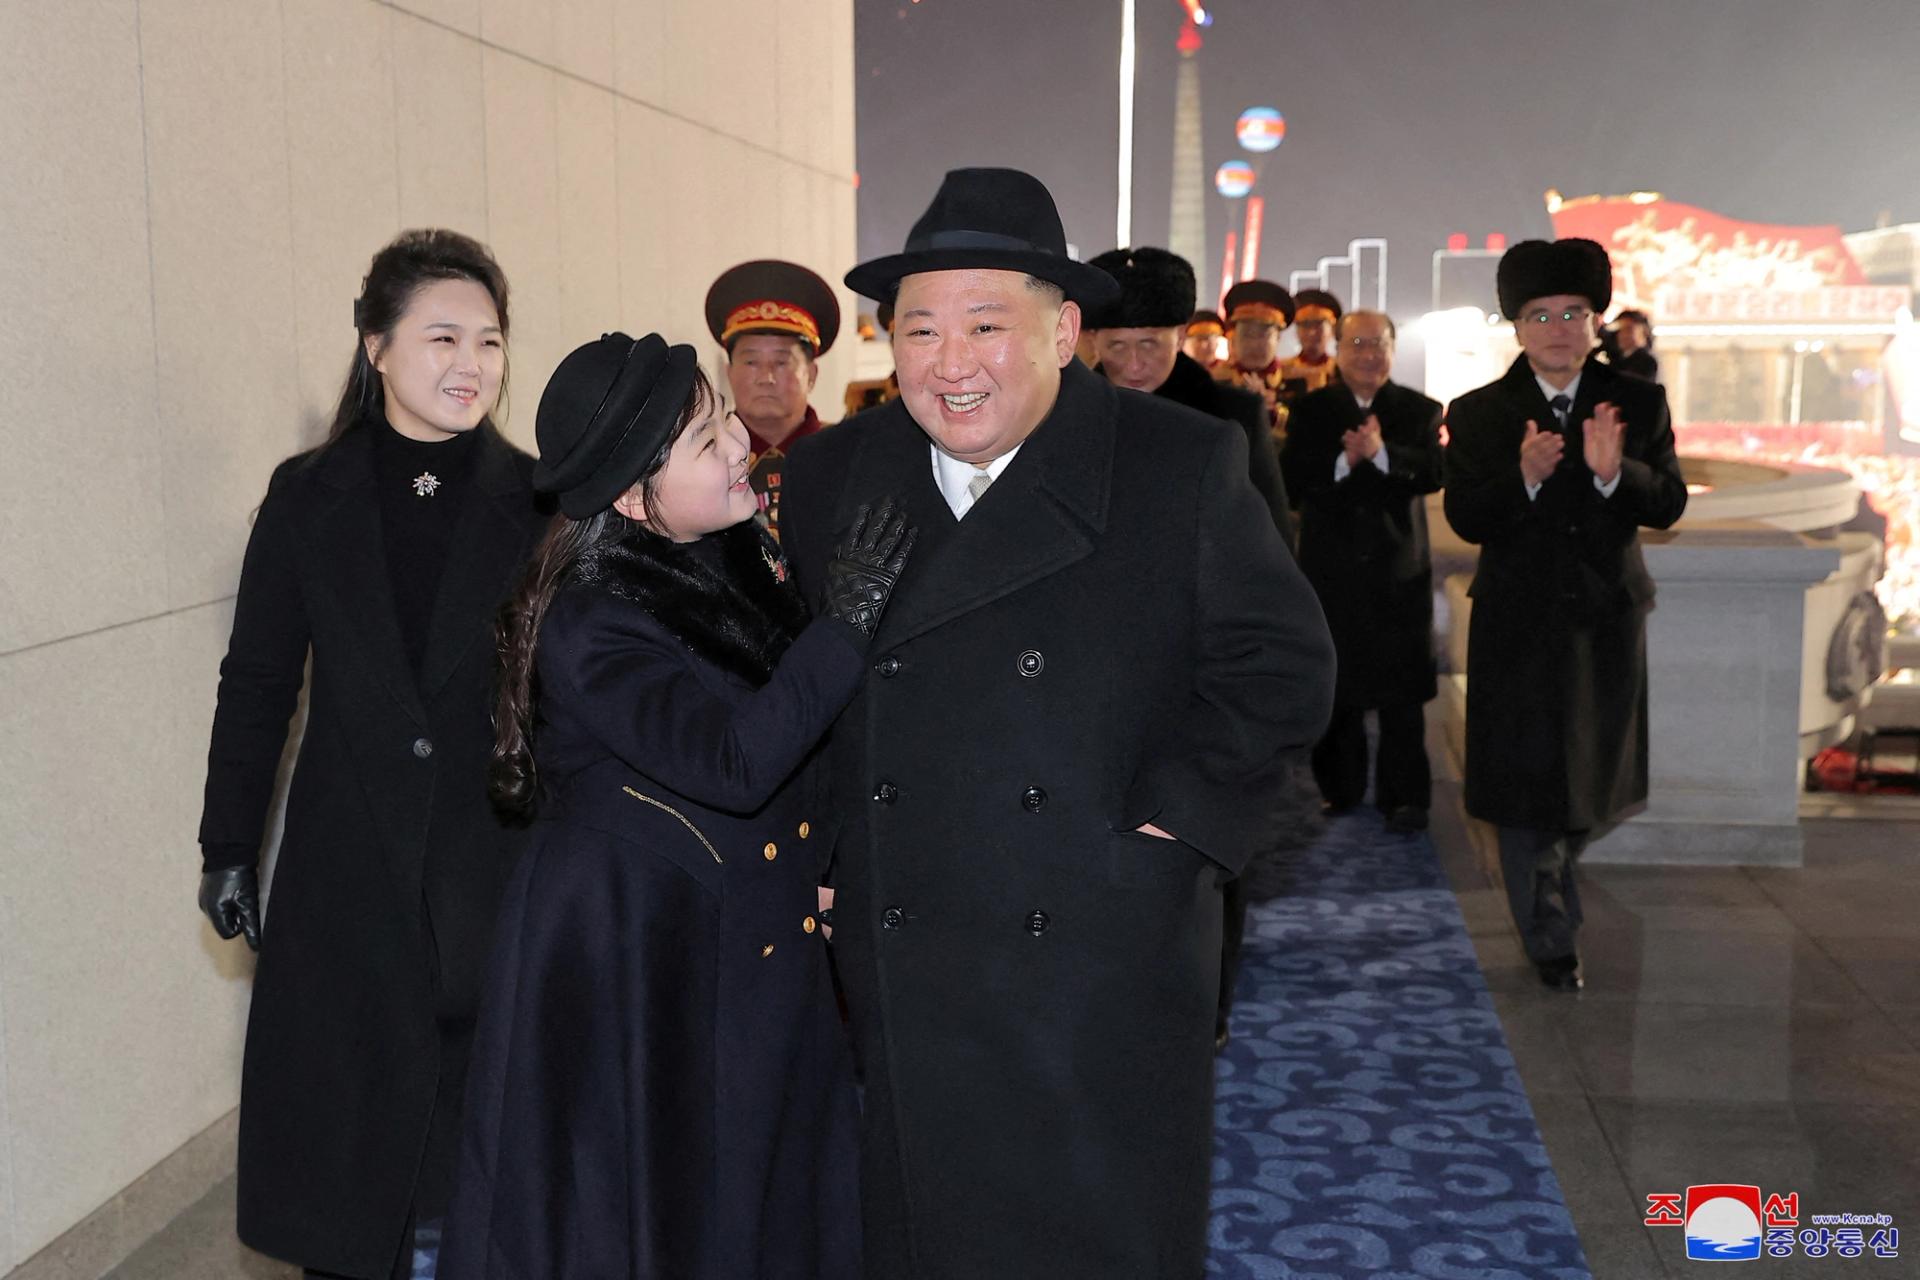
[871,363,1117,645]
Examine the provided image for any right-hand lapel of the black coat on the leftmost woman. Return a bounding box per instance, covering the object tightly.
[420,426,526,702]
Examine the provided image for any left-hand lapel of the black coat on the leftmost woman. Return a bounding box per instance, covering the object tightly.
[307,428,428,729]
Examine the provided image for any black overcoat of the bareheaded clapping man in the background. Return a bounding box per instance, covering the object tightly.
[1281,382,1440,706]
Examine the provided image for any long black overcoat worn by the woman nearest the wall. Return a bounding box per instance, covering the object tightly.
[200,424,545,1278]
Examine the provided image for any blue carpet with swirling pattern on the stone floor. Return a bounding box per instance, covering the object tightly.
[1208,810,1590,1280]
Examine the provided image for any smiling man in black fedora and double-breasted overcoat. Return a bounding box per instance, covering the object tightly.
[787,169,1332,1280]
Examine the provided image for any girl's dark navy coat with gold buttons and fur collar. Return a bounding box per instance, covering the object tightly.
[438,522,866,1280]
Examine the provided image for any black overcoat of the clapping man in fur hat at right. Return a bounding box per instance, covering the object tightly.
[1446,355,1686,831]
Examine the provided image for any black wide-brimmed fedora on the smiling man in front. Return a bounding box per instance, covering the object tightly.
[847,169,1119,311]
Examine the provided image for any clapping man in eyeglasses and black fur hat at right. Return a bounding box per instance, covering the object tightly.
[1446,240,1686,992]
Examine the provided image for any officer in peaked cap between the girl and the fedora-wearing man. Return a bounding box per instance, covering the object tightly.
[707,259,839,537]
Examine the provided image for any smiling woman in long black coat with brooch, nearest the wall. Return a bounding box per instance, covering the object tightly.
[200,230,543,1280]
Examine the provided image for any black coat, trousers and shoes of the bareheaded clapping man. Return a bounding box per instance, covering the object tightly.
[1281,382,1440,814]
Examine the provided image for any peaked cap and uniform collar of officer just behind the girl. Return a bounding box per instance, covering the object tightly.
[707,259,839,537]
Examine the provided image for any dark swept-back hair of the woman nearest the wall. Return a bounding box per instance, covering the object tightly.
[323,228,507,447]
